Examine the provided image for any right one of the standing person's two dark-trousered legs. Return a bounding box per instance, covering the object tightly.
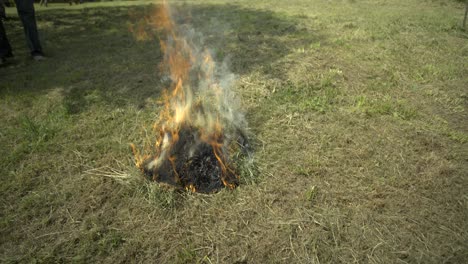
[16,0,42,56]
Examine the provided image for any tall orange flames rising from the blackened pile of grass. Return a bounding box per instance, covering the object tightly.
[132,1,236,192]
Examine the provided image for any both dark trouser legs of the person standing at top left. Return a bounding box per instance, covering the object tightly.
[0,0,42,57]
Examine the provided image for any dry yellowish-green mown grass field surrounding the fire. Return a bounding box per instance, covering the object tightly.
[0,0,468,263]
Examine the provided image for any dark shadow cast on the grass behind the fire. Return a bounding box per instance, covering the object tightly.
[0,4,317,114]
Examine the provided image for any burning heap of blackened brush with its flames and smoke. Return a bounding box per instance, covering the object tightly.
[132,3,247,193]
